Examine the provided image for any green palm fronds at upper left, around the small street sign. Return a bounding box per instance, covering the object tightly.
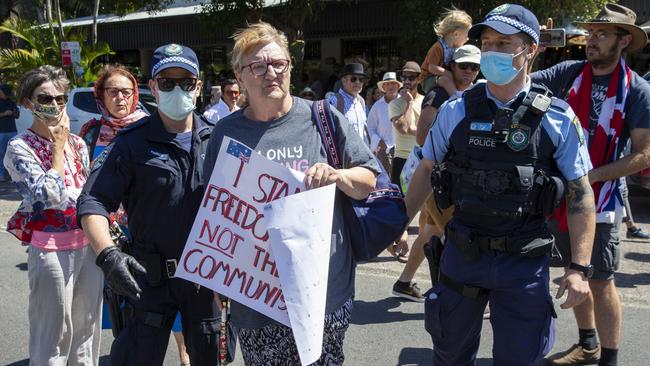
[0,18,115,86]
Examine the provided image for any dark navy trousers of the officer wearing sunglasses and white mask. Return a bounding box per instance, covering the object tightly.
[111,275,220,366]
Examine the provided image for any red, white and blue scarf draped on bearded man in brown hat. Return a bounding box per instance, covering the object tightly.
[556,58,632,231]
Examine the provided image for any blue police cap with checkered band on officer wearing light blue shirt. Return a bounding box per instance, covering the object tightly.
[469,4,539,43]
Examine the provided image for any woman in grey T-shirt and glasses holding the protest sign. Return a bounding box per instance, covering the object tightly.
[204,22,380,365]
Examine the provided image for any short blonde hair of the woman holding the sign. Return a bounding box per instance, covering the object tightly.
[230,22,290,73]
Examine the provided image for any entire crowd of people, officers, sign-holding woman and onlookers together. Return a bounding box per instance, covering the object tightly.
[0,4,650,365]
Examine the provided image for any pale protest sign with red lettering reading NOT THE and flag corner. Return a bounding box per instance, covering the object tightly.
[176,137,304,326]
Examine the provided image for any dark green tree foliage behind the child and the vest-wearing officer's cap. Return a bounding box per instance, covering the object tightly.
[399,0,610,62]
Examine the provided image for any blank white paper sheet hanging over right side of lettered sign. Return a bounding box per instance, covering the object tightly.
[264,184,336,365]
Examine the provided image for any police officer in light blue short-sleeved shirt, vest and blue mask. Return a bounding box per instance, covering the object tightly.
[406,4,594,365]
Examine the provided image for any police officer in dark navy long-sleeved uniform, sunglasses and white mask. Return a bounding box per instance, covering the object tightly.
[78,44,219,365]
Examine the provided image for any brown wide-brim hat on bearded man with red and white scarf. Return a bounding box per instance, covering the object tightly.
[573,4,648,52]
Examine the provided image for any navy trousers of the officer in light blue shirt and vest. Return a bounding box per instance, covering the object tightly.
[425,236,556,366]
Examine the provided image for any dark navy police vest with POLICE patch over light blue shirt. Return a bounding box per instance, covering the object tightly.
[445,84,563,235]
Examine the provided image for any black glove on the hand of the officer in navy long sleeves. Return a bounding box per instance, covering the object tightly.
[95,245,147,299]
